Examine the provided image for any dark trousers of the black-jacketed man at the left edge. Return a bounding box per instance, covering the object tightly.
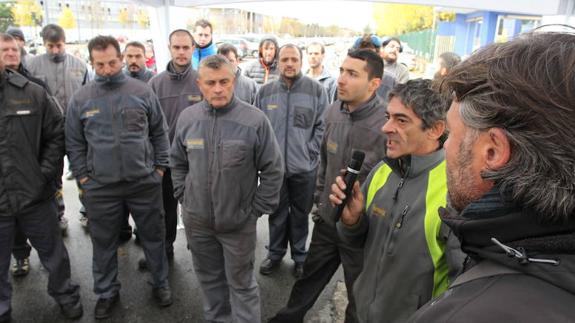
[0,199,80,315]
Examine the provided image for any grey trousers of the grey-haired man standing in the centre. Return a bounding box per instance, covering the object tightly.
[183,211,261,323]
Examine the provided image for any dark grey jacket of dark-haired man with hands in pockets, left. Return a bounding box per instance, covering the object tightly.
[66,71,169,184]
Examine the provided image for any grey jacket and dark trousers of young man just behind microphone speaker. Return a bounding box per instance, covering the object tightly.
[270,95,387,323]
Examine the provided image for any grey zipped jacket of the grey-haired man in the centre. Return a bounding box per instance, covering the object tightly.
[170,97,283,232]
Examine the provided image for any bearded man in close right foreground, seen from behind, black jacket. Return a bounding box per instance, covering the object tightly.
[411,32,575,323]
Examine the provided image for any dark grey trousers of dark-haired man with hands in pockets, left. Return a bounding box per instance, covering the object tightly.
[82,171,168,298]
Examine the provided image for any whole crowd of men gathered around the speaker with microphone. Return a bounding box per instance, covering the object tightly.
[0,20,575,323]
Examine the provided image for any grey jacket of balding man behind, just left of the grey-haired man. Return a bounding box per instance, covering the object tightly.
[148,61,202,143]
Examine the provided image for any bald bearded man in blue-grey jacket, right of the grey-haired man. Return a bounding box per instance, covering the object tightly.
[255,44,327,278]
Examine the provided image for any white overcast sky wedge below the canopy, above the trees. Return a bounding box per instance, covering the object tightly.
[207,1,373,31]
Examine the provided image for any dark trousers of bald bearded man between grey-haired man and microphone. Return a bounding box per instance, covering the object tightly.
[268,170,316,263]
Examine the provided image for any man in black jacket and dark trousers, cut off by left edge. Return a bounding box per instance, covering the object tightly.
[0,35,83,322]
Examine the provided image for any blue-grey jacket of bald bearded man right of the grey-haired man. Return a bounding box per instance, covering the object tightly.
[254,73,327,176]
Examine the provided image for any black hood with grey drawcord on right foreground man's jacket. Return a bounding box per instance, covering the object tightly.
[440,187,575,293]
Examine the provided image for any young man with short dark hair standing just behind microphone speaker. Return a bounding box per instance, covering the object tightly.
[270,50,387,323]
